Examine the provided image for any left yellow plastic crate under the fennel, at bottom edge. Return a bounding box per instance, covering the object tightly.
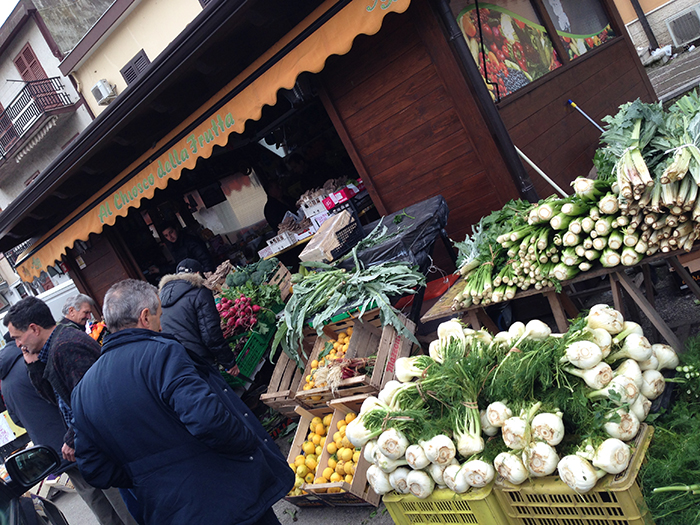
[383,483,509,525]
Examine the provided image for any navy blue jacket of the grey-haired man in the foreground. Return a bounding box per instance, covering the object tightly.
[73,328,294,525]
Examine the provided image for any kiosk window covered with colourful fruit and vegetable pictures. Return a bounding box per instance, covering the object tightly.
[451,0,615,101]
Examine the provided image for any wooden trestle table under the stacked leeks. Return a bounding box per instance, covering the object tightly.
[421,245,700,351]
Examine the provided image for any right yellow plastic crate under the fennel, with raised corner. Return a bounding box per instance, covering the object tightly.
[494,424,654,525]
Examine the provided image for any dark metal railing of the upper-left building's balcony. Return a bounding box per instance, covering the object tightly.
[0,77,72,157]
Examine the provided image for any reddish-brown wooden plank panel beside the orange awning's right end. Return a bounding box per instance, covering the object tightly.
[320,0,518,268]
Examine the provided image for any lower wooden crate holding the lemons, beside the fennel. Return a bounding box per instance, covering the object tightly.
[304,394,381,507]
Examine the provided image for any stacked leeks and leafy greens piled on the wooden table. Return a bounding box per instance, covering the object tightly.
[454,94,700,310]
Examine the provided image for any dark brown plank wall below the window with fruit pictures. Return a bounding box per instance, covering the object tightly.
[499,37,656,197]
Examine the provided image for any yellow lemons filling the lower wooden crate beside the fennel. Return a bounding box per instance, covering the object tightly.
[289,412,360,496]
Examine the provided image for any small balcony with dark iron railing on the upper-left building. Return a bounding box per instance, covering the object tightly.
[0,77,75,164]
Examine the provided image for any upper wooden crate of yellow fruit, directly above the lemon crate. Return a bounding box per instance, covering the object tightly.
[296,316,415,407]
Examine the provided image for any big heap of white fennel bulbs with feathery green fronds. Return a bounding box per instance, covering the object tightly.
[346,305,678,498]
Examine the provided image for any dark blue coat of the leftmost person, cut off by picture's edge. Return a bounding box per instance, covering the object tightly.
[0,341,70,467]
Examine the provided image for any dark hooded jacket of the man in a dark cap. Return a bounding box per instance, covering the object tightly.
[159,273,236,368]
